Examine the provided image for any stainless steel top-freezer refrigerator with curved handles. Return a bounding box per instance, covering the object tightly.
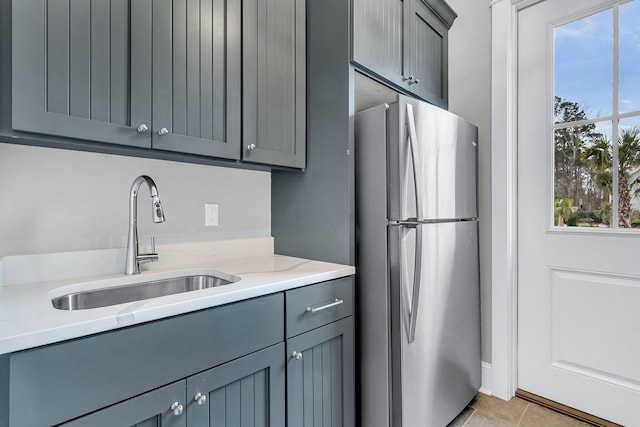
[355,95,481,427]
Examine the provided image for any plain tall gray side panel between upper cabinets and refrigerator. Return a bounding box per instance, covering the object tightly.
[271,0,354,264]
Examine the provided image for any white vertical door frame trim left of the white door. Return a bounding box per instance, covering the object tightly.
[489,0,543,400]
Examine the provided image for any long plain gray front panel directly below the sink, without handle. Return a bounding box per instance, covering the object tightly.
[10,294,284,427]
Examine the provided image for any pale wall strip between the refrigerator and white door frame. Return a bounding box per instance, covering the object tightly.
[448,0,491,362]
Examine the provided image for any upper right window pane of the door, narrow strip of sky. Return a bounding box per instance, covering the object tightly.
[618,0,640,113]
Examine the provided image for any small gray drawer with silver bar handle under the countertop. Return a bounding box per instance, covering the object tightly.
[285,277,353,338]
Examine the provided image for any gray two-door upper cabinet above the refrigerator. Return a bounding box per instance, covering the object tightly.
[352,0,457,107]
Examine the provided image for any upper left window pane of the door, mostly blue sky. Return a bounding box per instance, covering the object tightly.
[554,9,613,123]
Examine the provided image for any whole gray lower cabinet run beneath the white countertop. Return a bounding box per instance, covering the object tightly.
[0,277,355,427]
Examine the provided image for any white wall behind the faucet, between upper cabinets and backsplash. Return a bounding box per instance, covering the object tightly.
[0,144,271,258]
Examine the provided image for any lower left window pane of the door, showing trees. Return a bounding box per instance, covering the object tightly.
[553,122,612,227]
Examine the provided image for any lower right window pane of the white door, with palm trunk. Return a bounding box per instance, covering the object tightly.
[618,117,640,228]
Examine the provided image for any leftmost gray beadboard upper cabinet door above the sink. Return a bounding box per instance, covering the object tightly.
[12,0,151,147]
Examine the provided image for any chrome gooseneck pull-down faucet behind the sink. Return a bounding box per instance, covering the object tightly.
[124,175,164,274]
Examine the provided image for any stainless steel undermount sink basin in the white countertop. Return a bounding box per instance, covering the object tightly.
[51,275,240,310]
